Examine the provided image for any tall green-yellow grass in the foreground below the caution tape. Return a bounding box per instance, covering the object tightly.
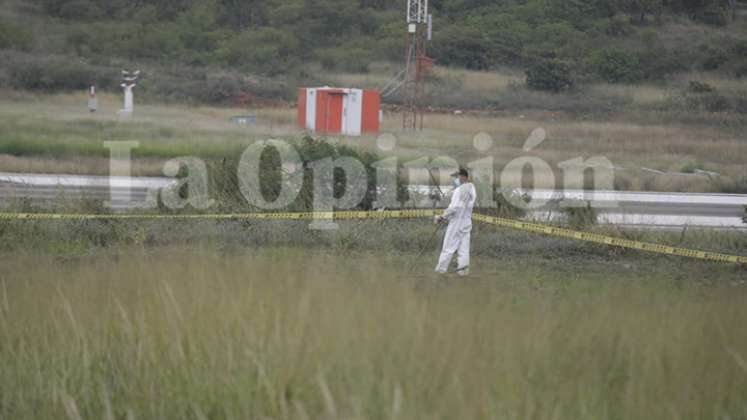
[0,247,747,420]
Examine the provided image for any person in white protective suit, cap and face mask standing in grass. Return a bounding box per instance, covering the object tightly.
[436,169,477,276]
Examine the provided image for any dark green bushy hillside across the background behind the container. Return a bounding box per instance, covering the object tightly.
[0,0,747,107]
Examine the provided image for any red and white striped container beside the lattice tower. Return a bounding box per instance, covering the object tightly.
[298,87,381,136]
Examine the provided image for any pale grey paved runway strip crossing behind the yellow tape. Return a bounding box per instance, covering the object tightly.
[0,173,747,229]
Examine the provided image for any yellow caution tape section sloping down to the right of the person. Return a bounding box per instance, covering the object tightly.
[473,214,747,264]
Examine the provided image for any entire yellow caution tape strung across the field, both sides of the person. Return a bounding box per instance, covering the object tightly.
[0,210,747,264]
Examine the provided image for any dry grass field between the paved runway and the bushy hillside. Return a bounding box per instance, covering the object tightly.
[0,79,747,192]
